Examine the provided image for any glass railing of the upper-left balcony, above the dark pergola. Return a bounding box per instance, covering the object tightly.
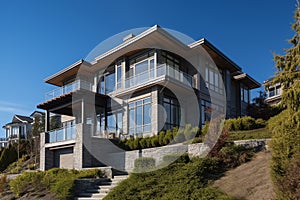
[46,80,92,101]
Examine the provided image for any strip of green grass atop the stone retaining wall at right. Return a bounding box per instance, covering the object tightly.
[227,128,272,142]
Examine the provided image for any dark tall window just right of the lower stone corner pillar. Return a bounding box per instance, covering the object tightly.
[163,96,180,130]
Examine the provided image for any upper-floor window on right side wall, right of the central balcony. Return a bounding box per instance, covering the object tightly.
[205,67,223,94]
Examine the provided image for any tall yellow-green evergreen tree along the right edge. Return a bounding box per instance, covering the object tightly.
[271,2,300,199]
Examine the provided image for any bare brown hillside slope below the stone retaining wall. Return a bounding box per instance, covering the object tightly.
[213,151,275,200]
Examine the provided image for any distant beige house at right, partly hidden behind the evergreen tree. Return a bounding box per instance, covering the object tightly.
[263,78,282,106]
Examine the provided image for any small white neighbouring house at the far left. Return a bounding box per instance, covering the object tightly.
[3,115,33,141]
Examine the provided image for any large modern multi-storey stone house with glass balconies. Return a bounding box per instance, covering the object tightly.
[37,26,260,170]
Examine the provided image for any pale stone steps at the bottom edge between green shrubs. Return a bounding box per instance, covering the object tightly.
[74,175,128,200]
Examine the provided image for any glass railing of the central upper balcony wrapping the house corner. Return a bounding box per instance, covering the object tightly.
[125,64,194,89]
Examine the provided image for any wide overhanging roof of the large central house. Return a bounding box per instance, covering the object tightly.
[45,25,260,88]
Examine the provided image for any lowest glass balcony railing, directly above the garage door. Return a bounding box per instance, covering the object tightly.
[48,125,76,143]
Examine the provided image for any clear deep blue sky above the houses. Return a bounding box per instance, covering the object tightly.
[0,0,295,137]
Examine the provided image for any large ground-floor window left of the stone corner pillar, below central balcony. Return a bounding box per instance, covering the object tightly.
[129,97,151,136]
